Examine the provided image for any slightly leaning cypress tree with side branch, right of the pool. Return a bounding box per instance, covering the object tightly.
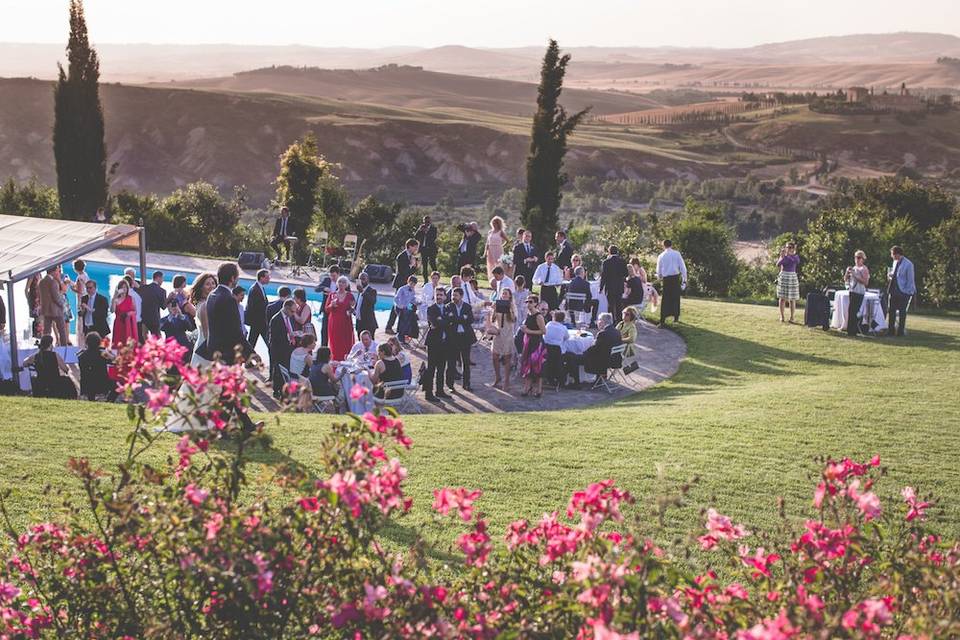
[522,40,590,246]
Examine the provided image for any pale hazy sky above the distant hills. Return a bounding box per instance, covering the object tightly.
[0,0,960,47]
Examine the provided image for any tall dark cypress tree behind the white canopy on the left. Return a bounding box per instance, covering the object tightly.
[53,0,107,220]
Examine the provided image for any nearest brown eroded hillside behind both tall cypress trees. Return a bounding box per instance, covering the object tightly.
[0,79,728,205]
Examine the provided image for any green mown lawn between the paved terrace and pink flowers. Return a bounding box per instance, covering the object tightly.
[0,301,960,542]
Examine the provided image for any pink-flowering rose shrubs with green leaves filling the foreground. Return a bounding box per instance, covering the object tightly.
[0,341,960,640]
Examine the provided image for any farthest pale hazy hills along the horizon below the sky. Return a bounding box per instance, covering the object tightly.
[0,33,960,85]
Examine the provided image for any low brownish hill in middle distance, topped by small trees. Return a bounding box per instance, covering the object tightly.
[167,65,659,115]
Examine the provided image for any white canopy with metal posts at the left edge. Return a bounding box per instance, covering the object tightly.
[0,215,147,390]
